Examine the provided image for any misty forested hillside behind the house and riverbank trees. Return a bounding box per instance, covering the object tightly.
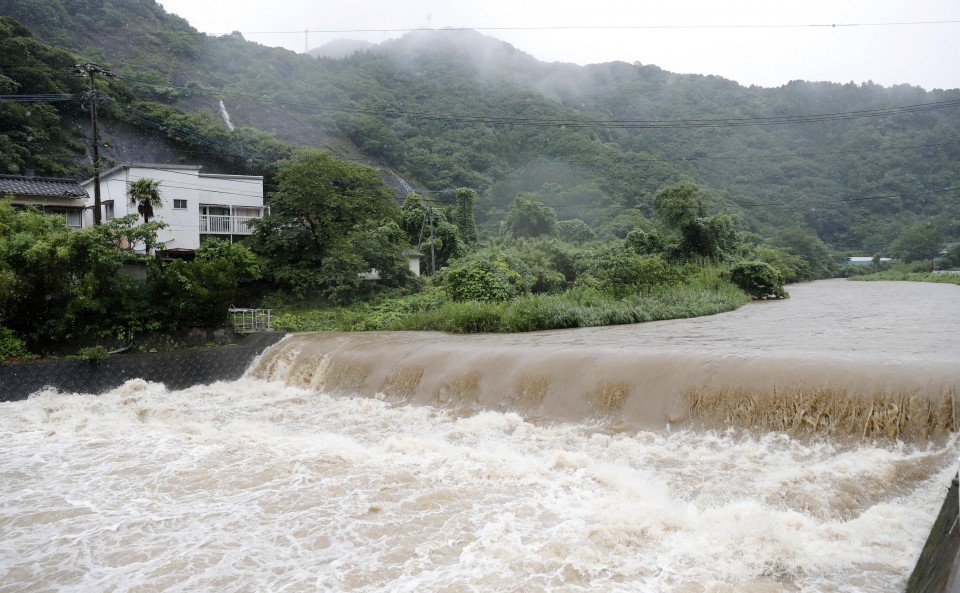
[0,0,960,254]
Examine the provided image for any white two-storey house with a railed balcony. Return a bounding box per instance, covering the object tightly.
[81,163,265,251]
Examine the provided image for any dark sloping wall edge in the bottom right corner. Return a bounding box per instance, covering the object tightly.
[906,478,960,593]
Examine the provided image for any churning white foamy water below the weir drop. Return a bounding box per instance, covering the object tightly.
[0,379,957,593]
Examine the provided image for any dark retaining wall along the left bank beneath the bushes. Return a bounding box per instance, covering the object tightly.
[0,332,284,401]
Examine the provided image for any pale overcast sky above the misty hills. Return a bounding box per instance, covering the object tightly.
[158,0,960,90]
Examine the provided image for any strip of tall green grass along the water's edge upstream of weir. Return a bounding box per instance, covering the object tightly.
[273,277,750,333]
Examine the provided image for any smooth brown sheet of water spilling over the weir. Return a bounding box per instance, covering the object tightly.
[247,332,960,441]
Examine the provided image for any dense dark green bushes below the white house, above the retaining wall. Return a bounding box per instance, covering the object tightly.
[0,201,259,357]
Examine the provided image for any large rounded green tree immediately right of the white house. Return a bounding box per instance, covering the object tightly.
[251,150,406,300]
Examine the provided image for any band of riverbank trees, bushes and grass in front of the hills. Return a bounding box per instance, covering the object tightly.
[0,150,833,357]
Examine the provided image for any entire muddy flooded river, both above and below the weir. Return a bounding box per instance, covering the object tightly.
[0,281,960,593]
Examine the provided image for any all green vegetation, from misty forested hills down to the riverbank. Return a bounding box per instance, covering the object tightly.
[0,0,960,344]
